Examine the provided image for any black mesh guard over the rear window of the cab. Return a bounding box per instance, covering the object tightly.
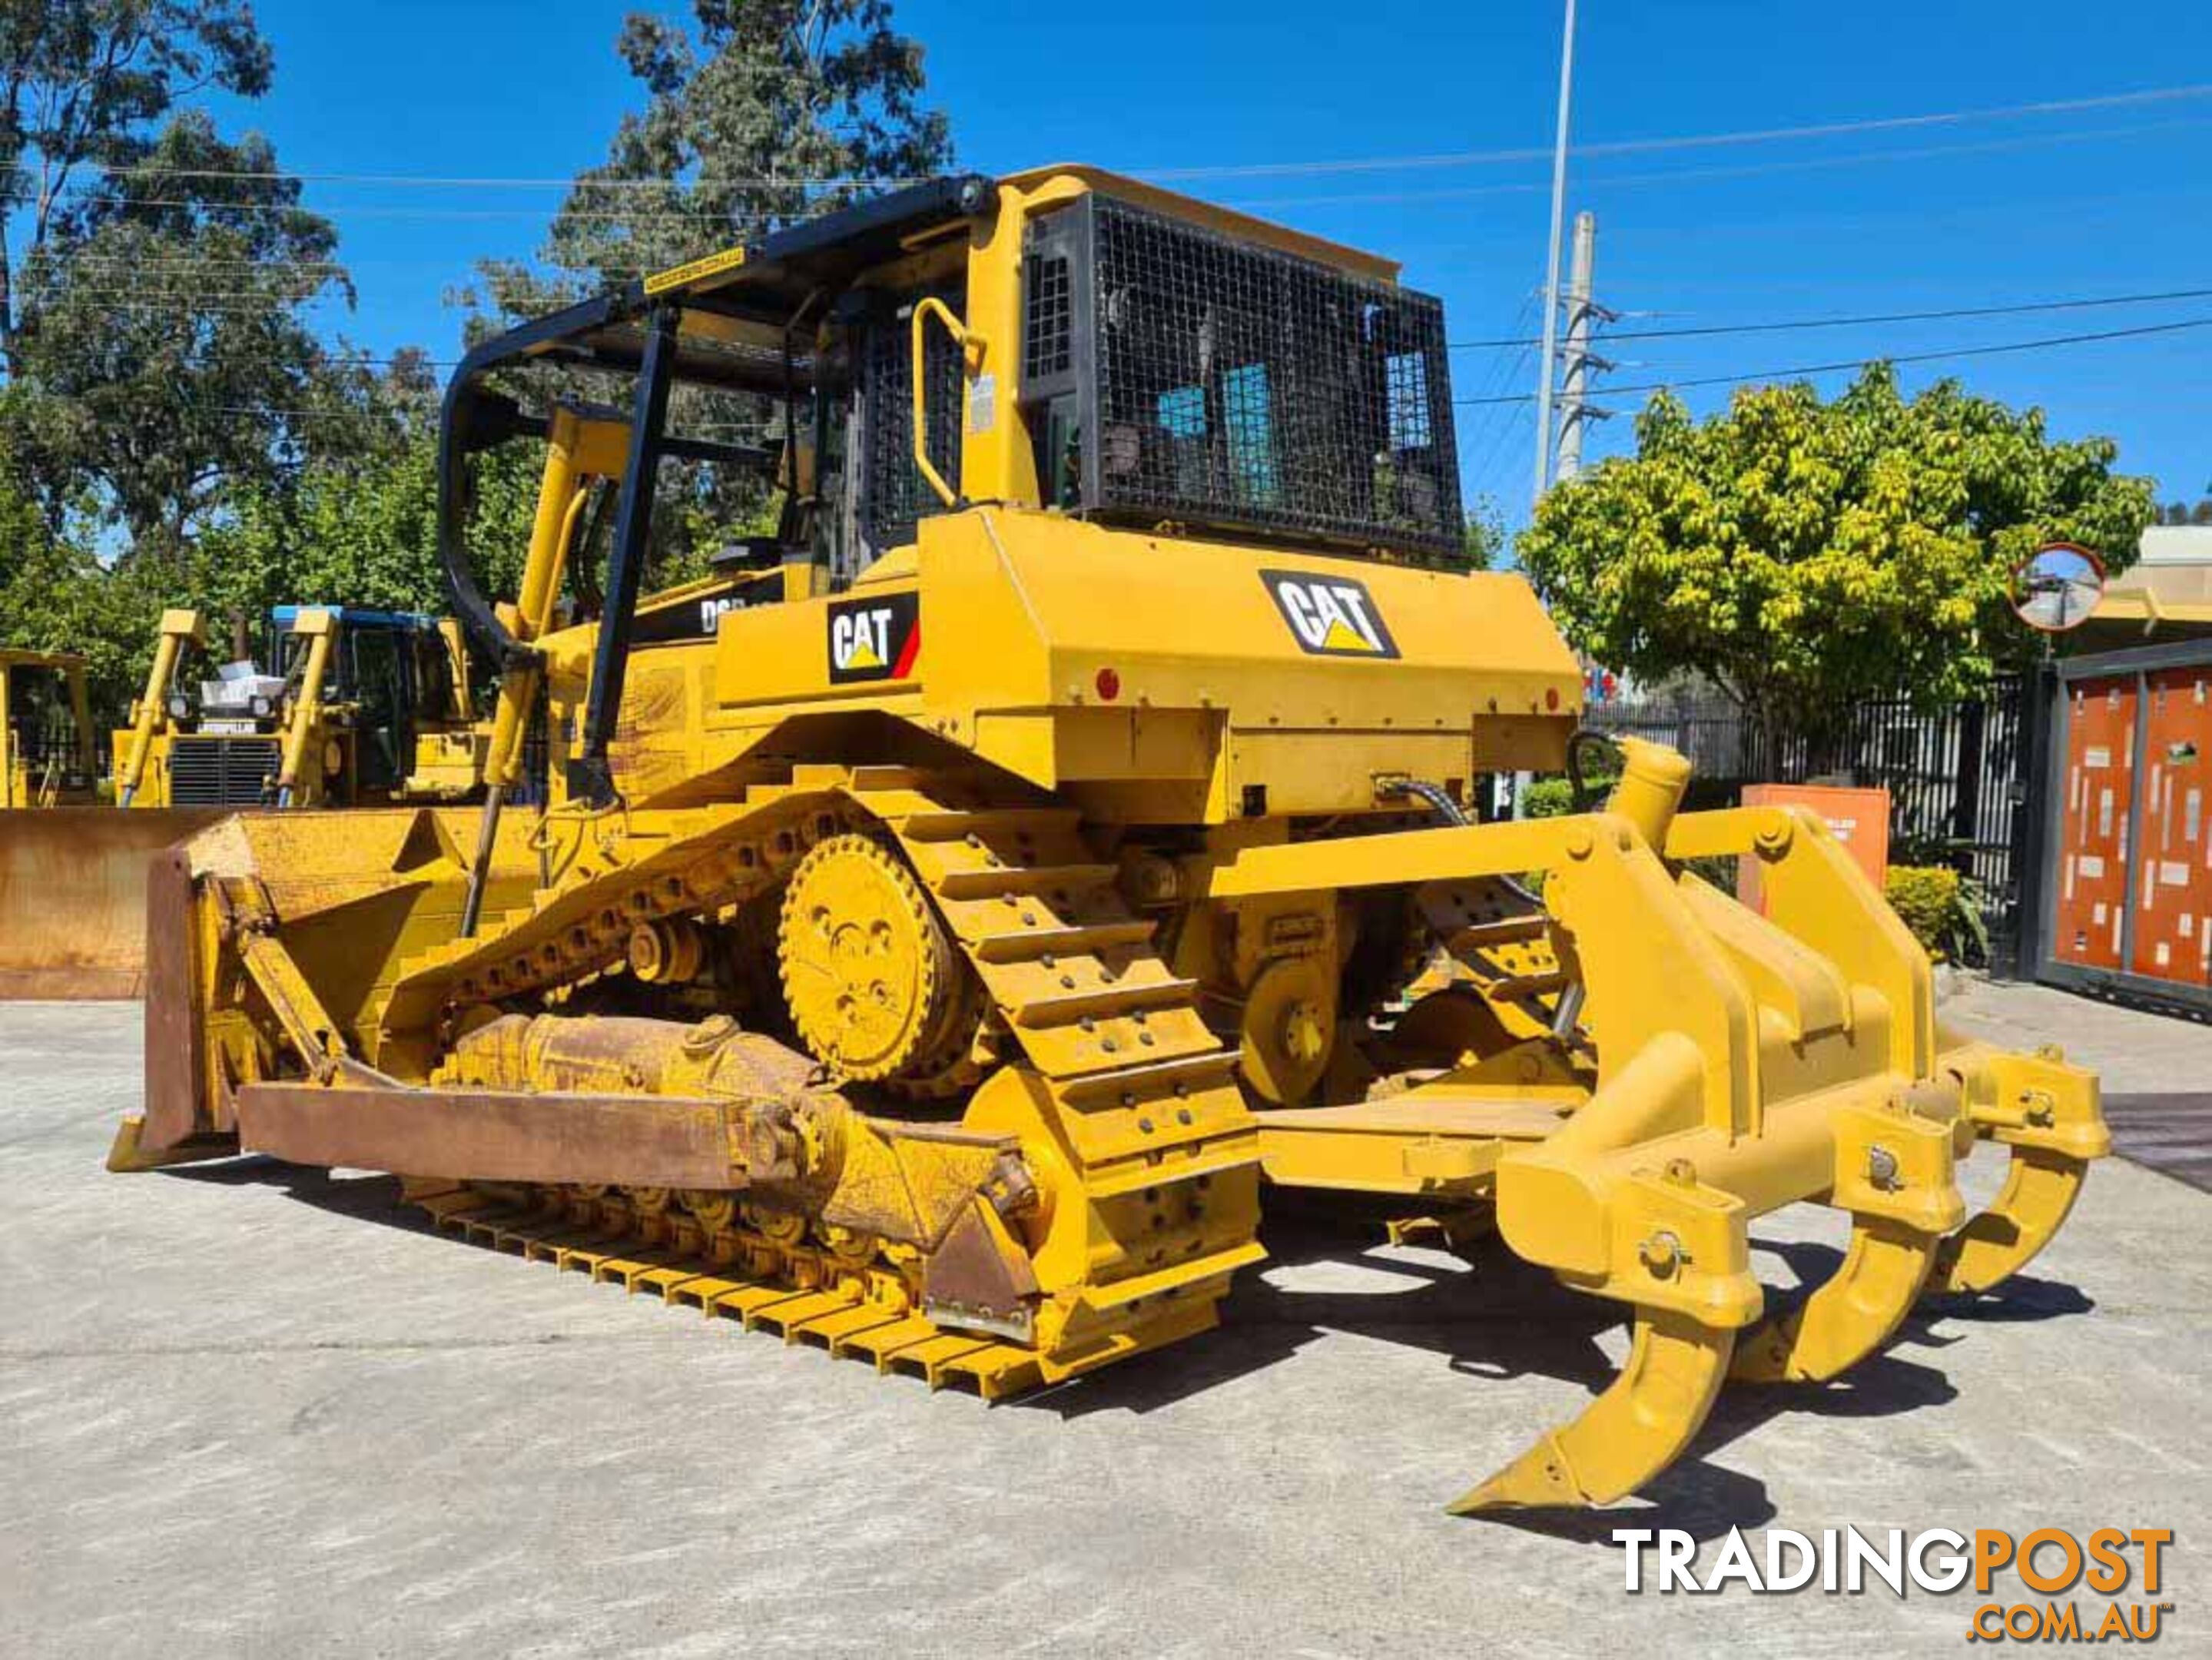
[1022,194,1462,553]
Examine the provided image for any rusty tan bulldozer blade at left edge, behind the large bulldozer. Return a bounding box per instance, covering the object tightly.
[0,808,228,1003]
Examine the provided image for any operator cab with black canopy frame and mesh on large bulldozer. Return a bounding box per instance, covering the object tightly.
[440,166,1462,802]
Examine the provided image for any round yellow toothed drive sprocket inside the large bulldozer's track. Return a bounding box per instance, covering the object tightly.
[777,835,980,1091]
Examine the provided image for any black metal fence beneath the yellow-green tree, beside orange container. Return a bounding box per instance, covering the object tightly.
[1588,675,2026,963]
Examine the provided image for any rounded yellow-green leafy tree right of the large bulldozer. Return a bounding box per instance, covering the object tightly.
[1517,365,2152,742]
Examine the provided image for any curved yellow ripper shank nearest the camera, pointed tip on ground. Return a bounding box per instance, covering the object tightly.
[1451,1308,1736,1516]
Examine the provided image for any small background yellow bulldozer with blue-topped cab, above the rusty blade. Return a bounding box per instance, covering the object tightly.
[113,604,491,808]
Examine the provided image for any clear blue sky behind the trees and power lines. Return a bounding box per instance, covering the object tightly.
[224,0,2212,520]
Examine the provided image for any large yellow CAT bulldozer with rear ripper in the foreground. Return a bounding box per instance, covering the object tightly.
[111,166,2108,1512]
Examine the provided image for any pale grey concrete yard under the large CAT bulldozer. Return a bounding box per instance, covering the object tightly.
[0,987,2212,1660]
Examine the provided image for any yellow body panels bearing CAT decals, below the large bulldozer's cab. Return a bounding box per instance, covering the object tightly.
[544,507,1581,825]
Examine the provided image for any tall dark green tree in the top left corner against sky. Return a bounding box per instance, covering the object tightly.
[0,0,376,563]
